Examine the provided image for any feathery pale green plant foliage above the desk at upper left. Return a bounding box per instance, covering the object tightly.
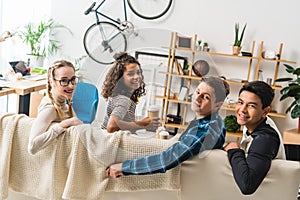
[18,19,72,57]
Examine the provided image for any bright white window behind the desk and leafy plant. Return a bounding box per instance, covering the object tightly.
[0,0,51,112]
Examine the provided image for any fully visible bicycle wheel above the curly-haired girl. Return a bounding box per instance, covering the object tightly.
[83,22,127,64]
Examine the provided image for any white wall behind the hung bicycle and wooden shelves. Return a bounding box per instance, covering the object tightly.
[34,0,300,134]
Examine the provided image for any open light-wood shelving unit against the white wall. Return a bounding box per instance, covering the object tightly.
[156,32,296,134]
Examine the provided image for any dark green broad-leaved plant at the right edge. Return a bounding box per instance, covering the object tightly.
[276,64,300,133]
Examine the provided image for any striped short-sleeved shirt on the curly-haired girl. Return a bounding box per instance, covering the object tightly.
[101,95,136,129]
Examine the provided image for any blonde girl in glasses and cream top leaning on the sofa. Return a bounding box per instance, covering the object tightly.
[28,60,83,154]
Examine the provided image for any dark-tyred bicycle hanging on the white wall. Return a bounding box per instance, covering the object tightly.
[83,0,173,64]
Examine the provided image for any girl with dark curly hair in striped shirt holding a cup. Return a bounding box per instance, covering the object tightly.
[101,52,159,133]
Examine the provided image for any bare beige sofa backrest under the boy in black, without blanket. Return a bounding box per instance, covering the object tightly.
[181,150,300,200]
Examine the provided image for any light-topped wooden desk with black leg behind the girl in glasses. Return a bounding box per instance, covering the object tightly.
[0,79,47,116]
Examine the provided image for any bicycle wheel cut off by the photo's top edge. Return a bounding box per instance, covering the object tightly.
[127,0,172,20]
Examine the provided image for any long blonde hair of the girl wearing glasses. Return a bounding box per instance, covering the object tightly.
[47,60,75,120]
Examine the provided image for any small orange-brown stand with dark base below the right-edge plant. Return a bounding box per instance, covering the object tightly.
[283,129,300,161]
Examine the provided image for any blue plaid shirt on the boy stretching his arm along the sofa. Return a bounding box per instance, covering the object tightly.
[122,113,226,175]
